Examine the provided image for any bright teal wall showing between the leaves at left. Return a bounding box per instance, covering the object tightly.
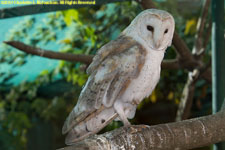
[0,5,60,84]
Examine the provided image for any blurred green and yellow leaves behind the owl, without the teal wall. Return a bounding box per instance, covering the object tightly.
[0,0,210,150]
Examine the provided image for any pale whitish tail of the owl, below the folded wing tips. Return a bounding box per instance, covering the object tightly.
[65,107,118,145]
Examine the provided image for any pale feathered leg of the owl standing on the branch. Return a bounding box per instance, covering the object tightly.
[114,101,131,126]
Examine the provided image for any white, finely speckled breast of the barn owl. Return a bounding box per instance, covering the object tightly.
[122,50,164,102]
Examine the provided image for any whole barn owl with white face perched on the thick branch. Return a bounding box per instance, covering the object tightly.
[62,9,175,145]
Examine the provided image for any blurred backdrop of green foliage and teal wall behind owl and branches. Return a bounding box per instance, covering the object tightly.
[0,0,212,150]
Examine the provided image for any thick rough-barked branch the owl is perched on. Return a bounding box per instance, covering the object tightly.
[60,111,225,150]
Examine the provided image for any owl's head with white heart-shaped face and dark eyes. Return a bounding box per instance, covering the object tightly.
[123,9,175,50]
